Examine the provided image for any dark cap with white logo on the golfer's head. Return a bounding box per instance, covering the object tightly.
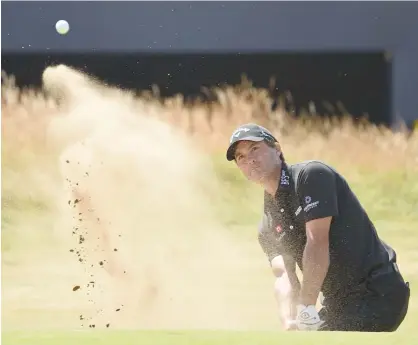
[226,123,277,161]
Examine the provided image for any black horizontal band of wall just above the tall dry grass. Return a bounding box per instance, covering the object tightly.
[2,53,390,124]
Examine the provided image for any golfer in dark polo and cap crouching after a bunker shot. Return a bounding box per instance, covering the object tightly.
[226,124,410,332]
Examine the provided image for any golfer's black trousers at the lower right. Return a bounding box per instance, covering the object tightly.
[319,272,410,332]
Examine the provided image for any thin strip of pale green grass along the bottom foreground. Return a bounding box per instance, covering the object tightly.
[2,331,418,345]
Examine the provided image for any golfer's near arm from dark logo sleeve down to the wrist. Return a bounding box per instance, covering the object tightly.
[298,162,338,306]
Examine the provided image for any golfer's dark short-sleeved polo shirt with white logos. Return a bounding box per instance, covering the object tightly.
[258,161,396,299]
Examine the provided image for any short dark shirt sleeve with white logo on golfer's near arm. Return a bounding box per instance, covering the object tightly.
[297,162,338,222]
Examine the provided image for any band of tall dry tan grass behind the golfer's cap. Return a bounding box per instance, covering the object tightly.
[2,68,418,175]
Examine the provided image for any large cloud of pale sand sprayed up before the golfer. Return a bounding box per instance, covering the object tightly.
[3,66,273,328]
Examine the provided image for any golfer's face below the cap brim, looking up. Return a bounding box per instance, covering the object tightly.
[235,140,280,183]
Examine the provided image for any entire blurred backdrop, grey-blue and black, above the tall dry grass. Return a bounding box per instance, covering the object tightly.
[2,1,418,124]
